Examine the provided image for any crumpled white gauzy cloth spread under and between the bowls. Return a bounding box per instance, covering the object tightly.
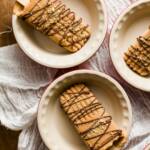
[0,0,150,150]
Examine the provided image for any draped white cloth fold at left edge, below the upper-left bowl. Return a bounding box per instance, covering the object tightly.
[0,44,57,130]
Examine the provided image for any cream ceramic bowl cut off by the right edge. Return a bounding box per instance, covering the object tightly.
[110,0,150,92]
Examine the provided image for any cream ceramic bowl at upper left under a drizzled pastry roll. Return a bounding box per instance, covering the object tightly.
[13,0,107,68]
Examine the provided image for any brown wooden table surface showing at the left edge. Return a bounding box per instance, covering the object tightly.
[0,0,19,150]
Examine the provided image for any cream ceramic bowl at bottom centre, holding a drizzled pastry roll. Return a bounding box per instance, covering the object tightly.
[38,70,132,150]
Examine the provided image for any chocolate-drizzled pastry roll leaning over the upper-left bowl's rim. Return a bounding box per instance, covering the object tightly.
[14,0,91,52]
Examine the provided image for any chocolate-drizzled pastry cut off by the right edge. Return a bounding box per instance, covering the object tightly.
[124,27,150,76]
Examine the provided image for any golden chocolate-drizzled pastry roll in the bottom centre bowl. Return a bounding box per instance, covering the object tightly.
[60,84,127,150]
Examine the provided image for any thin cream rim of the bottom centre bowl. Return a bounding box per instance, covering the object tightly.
[37,69,133,150]
